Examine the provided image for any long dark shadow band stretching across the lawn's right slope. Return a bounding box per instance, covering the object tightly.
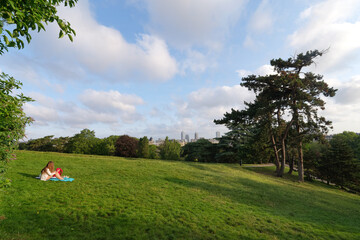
[165,174,360,232]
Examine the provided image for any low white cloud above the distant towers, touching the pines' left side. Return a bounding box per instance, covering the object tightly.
[141,85,254,139]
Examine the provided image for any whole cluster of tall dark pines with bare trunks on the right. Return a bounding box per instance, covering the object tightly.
[215,50,336,181]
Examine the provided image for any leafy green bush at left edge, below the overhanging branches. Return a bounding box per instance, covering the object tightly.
[0,73,33,187]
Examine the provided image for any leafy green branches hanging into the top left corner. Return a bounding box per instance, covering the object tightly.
[0,0,77,55]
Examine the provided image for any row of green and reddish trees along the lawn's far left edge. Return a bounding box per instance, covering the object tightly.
[19,129,181,160]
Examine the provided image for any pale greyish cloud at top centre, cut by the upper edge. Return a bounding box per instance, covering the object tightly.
[143,0,247,50]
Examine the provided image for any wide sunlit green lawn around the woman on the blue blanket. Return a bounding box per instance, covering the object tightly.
[0,151,360,240]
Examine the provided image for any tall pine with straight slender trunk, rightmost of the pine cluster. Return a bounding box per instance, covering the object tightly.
[271,50,337,181]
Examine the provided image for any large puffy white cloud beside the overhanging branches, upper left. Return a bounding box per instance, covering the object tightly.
[34,0,178,81]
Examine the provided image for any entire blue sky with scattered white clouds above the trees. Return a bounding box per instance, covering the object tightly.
[0,0,360,139]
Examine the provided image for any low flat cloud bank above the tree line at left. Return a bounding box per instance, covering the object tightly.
[24,89,144,128]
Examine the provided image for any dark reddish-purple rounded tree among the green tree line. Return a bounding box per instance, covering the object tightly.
[115,135,139,157]
